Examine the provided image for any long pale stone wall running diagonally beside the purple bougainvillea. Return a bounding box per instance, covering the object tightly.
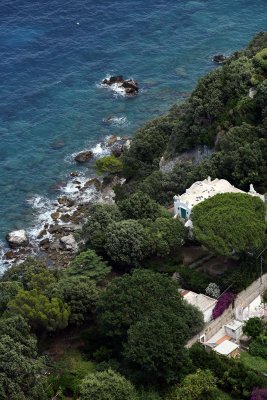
[186,274,267,347]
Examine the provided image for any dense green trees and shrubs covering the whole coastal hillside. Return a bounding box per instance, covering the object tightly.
[0,33,267,400]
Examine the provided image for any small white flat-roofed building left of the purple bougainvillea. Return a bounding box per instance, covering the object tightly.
[180,289,217,322]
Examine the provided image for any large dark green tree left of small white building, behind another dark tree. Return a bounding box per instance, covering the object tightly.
[98,269,203,340]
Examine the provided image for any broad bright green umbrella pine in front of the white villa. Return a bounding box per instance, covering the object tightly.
[191,193,266,257]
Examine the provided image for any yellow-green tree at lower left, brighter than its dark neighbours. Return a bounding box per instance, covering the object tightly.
[8,289,70,331]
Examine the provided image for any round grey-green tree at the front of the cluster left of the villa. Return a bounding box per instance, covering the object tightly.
[105,220,151,267]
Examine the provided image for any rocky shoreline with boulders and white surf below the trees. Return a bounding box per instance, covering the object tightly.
[3,135,131,268]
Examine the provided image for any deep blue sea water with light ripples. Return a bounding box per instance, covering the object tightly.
[0,0,267,245]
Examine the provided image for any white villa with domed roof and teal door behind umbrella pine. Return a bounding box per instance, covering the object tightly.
[173,176,264,228]
